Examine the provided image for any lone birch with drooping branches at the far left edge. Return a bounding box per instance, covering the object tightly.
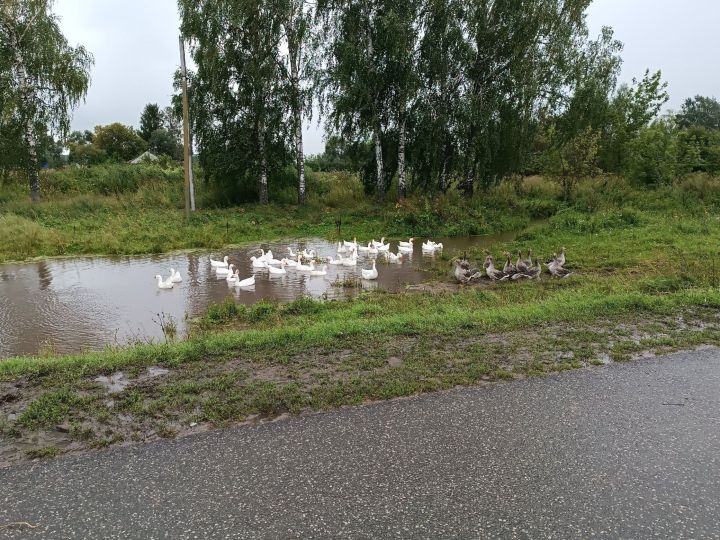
[0,0,93,201]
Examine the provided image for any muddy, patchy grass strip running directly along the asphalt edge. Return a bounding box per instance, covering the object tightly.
[0,308,720,467]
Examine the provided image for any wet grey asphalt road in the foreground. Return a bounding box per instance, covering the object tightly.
[0,349,720,539]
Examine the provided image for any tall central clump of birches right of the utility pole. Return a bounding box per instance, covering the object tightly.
[178,0,708,203]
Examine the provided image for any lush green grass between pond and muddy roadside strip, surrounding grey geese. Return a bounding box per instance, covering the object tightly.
[0,173,720,380]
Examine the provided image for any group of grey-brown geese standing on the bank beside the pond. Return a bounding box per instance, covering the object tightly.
[455,248,572,283]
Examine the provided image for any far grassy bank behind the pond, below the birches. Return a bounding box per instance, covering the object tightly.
[0,165,563,262]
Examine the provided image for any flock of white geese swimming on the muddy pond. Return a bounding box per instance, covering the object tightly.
[155,237,443,289]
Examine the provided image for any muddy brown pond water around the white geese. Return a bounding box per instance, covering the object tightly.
[0,229,528,357]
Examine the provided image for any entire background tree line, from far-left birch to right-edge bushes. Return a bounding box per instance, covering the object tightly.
[0,0,720,204]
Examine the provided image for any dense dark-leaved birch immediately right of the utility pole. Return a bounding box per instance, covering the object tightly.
[178,0,287,204]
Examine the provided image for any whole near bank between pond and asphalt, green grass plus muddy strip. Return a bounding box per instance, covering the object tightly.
[0,170,720,463]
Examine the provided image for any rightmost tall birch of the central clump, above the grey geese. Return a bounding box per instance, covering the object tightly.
[461,0,591,195]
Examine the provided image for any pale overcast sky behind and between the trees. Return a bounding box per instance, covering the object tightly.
[55,0,720,154]
